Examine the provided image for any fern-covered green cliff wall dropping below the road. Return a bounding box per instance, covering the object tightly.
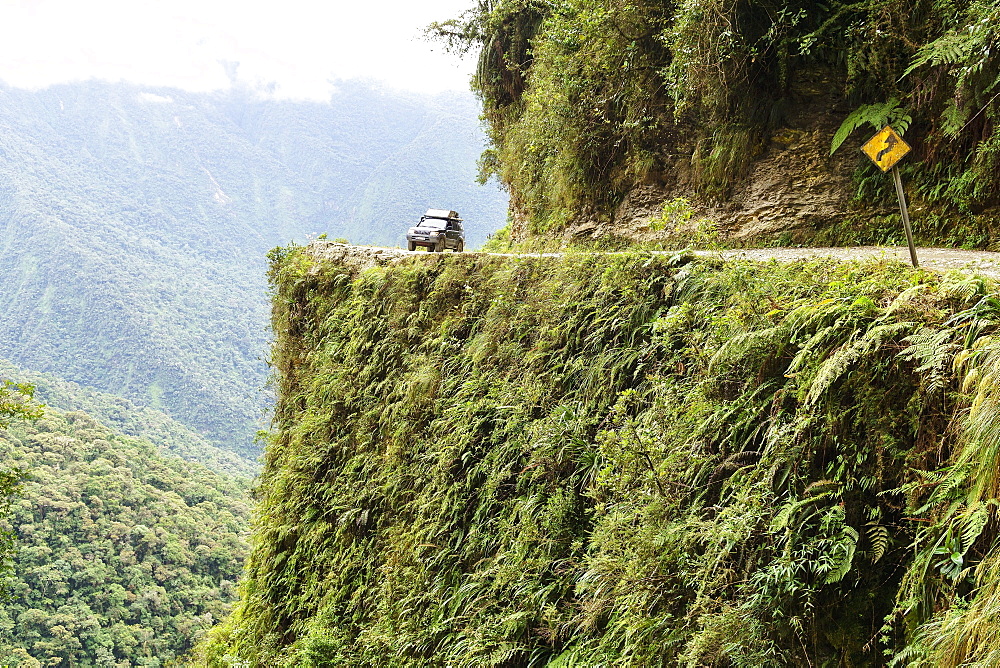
[207,248,1000,668]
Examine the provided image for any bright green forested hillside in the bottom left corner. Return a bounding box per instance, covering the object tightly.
[0,408,249,667]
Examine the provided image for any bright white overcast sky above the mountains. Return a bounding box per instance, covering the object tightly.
[0,0,475,100]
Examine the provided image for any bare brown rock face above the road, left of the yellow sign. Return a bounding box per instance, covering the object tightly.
[552,60,932,245]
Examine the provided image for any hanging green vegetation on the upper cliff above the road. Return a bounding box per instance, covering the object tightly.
[432,0,1000,240]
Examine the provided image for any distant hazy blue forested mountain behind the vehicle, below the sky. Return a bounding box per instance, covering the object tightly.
[0,82,506,457]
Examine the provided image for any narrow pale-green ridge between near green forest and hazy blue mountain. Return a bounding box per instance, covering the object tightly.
[0,359,260,479]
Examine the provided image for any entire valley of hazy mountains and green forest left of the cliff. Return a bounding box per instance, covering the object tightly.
[0,77,506,666]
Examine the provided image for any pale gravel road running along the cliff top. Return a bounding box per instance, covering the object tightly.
[309,240,1000,280]
